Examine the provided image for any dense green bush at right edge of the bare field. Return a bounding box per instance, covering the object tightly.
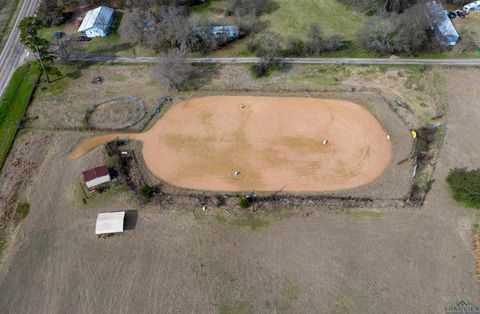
[446,168,480,209]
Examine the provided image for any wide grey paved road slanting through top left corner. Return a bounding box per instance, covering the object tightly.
[0,0,40,95]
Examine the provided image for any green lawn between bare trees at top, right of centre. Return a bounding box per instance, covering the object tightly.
[264,0,366,40]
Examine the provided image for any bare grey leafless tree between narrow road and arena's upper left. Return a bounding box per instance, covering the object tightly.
[154,48,193,90]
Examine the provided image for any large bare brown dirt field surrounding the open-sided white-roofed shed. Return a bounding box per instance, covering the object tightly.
[0,68,480,313]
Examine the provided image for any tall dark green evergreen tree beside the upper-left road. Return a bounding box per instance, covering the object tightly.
[18,16,54,83]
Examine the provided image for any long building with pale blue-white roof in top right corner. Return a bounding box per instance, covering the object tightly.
[427,1,460,46]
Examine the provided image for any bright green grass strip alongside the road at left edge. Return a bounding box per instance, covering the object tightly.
[0,63,41,169]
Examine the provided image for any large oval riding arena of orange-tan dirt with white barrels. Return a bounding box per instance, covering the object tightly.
[73,96,392,192]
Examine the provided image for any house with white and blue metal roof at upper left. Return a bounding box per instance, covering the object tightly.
[78,6,114,38]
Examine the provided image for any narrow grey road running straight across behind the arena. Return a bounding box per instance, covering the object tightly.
[72,55,480,66]
